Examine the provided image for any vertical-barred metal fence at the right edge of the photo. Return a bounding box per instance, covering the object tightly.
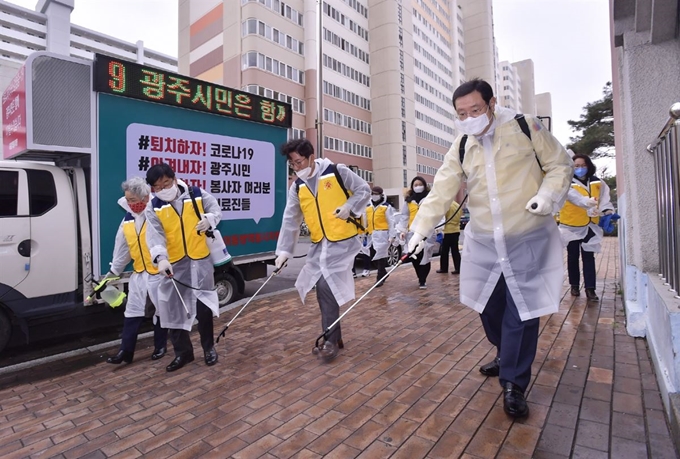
[647,102,680,298]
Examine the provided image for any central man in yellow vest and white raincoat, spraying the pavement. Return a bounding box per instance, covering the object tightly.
[275,139,371,362]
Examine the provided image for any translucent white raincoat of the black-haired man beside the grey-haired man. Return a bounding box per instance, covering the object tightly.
[145,179,222,331]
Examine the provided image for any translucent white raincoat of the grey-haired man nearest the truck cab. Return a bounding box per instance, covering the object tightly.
[109,197,158,318]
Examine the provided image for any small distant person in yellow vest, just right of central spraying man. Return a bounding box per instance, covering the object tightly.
[366,186,396,287]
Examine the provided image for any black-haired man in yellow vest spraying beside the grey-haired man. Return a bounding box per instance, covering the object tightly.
[146,163,222,371]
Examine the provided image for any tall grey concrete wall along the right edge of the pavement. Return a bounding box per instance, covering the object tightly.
[610,0,680,447]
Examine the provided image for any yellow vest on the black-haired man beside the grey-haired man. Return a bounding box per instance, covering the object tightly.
[151,187,210,263]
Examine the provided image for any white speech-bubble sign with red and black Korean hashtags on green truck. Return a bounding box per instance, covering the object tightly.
[126,123,276,223]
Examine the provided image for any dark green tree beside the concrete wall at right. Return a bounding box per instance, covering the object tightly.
[567,81,614,158]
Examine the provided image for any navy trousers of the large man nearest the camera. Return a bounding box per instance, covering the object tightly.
[480,275,539,391]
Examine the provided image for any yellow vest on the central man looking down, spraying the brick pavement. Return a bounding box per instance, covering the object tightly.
[295,164,358,244]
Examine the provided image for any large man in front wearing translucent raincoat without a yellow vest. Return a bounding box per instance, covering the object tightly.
[409,79,573,417]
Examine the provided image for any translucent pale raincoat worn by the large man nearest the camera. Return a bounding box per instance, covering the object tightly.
[411,106,574,320]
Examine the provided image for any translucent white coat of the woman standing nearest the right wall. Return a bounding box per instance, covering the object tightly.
[560,177,614,253]
